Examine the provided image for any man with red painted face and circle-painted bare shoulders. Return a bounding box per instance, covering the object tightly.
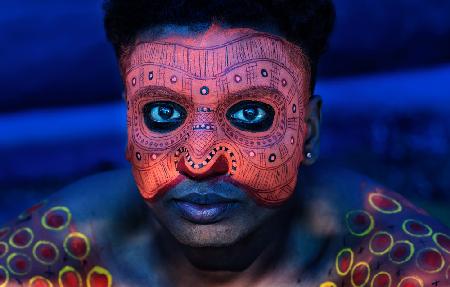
[0,0,450,287]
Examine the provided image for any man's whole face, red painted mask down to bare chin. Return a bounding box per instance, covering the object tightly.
[124,25,310,246]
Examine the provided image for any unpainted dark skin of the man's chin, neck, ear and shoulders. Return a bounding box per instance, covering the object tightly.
[0,25,448,287]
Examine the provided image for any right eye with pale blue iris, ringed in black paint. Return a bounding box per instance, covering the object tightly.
[226,101,275,132]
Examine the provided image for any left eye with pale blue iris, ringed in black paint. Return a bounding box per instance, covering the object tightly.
[142,101,187,133]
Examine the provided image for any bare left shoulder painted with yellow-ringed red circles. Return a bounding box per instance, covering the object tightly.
[0,171,144,287]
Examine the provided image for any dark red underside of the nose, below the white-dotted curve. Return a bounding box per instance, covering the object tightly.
[177,155,228,180]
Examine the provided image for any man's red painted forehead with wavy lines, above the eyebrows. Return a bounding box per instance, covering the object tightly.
[124,25,310,103]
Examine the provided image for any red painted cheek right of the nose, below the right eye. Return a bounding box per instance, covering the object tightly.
[218,84,307,206]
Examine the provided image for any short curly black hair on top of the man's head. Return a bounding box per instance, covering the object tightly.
[103,0,335,85]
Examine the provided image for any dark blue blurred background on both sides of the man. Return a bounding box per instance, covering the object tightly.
[0,0,450,223]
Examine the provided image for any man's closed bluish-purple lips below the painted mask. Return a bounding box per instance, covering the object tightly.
[173,193,238,224]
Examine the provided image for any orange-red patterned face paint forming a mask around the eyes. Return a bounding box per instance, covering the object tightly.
[125,31,310,206]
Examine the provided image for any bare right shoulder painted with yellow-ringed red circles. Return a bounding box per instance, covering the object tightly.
[316,169,450,287]
